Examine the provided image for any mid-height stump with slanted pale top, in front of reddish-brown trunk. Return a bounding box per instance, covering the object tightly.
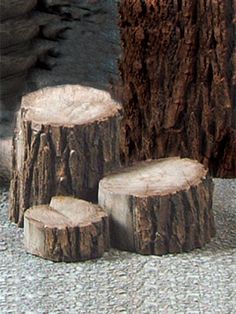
[99,157,215,255]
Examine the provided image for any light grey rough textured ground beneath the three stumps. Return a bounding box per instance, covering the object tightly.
[0,179,236,314]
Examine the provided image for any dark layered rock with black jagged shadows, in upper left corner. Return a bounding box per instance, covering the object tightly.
[0,0,72,137]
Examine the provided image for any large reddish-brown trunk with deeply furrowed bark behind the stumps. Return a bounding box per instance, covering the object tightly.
[119,0,236,177]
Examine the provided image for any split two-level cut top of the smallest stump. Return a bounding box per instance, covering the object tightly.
[25,196,107,228]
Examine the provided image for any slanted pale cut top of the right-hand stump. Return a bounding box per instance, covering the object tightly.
[99,157,207,197]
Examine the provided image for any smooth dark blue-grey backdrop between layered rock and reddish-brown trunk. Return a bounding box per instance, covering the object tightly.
[28,0,120,94]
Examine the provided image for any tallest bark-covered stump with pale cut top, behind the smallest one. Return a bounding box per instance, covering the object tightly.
[10,85,121,226]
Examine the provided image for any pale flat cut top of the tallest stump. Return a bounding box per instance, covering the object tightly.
[22,85,121,125]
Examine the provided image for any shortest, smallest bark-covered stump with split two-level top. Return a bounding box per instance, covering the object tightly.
[24,197,109,262]
